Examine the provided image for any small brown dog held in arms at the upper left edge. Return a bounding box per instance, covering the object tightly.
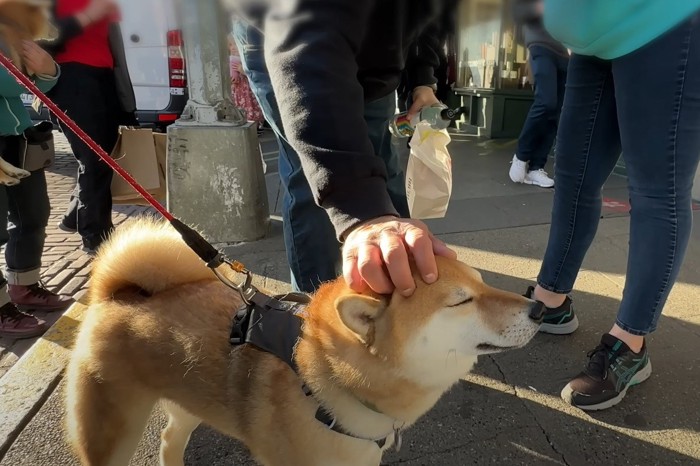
[0,0,56,186]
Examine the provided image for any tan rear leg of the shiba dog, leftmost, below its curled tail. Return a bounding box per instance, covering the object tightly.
[66,367,157,466]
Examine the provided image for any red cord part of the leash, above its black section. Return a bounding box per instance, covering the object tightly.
[0,53,173,221]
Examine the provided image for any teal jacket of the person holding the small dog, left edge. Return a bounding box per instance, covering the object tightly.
[0,66,60,136]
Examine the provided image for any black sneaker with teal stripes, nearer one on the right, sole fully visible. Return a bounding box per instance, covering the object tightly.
[561,333,651,411]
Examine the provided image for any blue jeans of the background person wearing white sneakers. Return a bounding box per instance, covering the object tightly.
[516,45,569,170]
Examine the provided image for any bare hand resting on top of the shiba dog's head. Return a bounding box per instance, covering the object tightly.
[343,216,457,296]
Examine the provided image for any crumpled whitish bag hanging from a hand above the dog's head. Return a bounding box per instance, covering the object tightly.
[406,121,452,219]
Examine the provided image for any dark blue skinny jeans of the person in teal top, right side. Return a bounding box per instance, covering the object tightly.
[538,17,700,335]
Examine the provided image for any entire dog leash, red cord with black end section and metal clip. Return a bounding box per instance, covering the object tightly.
[0,53,252,292]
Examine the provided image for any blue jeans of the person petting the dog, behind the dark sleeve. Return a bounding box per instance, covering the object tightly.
[233,21,409,292]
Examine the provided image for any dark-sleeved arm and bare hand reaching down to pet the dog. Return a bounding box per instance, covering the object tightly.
[265,0,456,296]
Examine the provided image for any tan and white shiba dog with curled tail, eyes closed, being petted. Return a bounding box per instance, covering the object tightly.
[66,219,539,466]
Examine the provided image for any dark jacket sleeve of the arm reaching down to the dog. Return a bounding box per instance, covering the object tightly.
[265,0,397,240]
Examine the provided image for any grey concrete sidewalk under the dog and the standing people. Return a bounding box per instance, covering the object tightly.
[0,133,700,466]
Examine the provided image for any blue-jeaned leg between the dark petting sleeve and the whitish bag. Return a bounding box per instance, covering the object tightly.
[365,92,410,218]
